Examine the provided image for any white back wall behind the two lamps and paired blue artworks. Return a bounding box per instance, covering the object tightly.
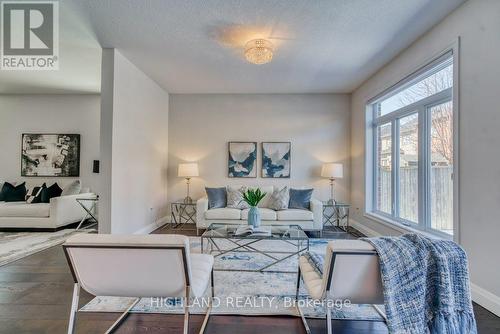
[168,94,350,205]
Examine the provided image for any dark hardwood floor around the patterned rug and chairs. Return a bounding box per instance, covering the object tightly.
[0,229,500,334]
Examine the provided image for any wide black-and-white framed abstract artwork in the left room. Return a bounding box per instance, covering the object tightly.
[21,133,80,177]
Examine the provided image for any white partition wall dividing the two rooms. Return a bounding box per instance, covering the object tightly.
[99,49,169,234]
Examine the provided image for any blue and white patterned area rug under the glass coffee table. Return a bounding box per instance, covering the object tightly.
[81,237,383,321]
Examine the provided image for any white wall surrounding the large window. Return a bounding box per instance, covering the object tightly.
[351,0,500,315]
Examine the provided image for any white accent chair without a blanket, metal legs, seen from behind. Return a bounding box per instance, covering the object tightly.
[63,234,214,334]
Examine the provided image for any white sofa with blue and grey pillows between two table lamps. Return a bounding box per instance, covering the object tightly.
[196,186,323,232]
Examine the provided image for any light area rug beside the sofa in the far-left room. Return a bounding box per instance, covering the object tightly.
[0,229,95,266]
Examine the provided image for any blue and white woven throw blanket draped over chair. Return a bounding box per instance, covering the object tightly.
[363,234,477,334]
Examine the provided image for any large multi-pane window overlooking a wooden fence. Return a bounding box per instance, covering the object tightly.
[367,52,454,235]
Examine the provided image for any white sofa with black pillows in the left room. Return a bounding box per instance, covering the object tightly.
[0,192,96,231]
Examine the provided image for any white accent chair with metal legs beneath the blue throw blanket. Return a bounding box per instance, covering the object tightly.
[296,240,387,334]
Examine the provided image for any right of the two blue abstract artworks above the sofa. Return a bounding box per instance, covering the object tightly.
[262,142,292,178]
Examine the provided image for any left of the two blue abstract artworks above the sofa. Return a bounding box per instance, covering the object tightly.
[228,141,257,177]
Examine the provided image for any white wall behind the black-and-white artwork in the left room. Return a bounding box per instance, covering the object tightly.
[0,95,100,191]
